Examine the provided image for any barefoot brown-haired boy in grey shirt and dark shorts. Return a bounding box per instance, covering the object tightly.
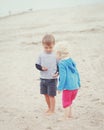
[36,35,57,115]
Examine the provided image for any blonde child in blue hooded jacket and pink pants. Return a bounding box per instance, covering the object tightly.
[56,43,80,119]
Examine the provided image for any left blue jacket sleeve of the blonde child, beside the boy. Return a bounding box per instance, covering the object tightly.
[57,64,66,91]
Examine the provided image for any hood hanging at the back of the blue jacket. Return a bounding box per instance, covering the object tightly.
[62,58,76,73]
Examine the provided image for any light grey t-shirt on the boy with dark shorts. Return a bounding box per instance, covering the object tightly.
[36,52,57,79]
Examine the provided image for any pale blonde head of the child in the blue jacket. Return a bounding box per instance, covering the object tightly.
[55,41,70,59]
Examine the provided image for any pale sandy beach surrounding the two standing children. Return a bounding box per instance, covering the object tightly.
[0,4,104,130]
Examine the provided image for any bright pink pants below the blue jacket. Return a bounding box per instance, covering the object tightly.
[62,89,78,108]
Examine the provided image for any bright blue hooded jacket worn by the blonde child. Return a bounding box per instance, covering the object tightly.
[57,58,81,91]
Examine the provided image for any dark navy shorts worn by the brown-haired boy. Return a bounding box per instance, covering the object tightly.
[40,79,57,96]
